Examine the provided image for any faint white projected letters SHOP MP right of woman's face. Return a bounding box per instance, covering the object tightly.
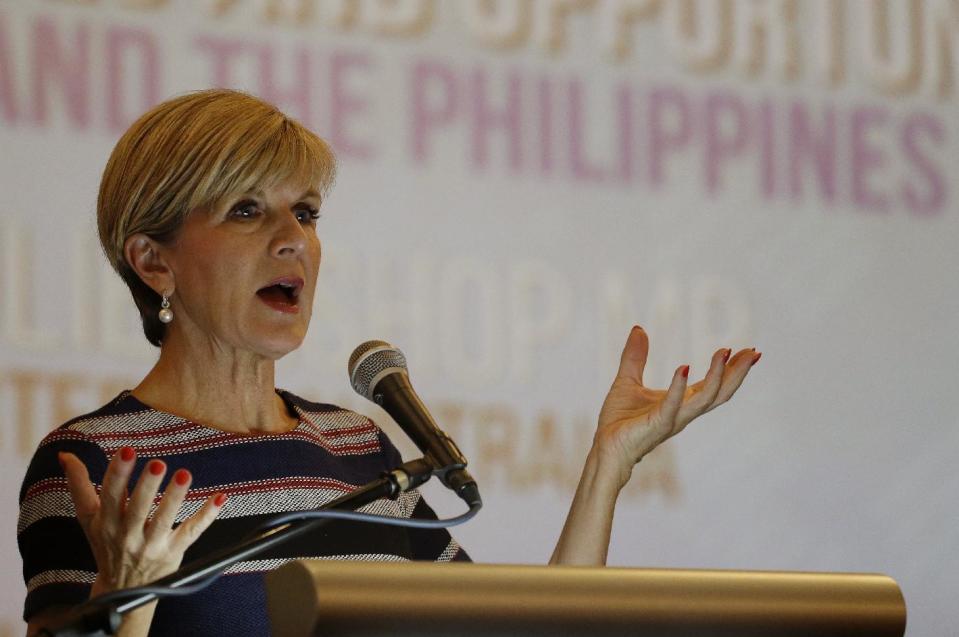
[305,246,754,388]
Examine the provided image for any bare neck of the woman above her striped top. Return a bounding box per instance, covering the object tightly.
[133,332,297,433]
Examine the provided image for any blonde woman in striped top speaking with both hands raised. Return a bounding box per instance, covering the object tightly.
[18,90,759,635]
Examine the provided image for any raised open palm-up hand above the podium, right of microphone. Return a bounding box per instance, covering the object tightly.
[593,325,761,487]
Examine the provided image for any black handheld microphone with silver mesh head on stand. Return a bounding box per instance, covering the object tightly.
[347,341,482,508]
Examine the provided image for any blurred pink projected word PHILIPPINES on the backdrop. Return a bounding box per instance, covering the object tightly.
[410,60,949,215]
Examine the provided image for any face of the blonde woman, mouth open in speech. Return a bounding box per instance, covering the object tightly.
[165,183,320,360]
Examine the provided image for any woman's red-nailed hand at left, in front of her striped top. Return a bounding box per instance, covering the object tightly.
[59,447,226,597]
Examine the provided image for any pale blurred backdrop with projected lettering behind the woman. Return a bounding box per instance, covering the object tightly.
[0,0,959,637]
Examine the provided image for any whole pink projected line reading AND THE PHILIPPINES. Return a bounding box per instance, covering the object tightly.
[0,12,944,217]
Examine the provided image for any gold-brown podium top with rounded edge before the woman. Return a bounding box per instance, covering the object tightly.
[266,560,906,637]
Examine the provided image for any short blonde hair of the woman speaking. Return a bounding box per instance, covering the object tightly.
[97,89,336,346]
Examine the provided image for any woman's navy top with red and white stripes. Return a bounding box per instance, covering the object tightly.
[17,390,469,635]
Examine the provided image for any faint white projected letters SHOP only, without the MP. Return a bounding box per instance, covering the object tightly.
[307,251,586,386]
